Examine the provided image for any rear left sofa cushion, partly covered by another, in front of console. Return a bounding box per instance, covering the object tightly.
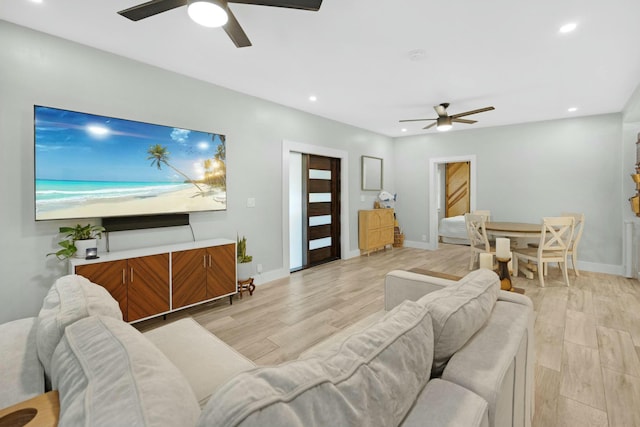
[37,274,122,378]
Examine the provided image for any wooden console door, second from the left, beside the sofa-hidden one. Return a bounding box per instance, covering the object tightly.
[127,253,169,322]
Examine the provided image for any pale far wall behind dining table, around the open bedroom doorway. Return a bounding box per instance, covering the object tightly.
[394,114,630,273]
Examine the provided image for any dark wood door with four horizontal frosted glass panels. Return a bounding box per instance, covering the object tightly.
[303,154,340,268]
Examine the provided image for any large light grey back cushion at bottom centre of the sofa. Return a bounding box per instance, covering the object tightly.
[198,301,433,426]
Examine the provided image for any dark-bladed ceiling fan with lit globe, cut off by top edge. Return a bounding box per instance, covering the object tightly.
[118,0,322,47]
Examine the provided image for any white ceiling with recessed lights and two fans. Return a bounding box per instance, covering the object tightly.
[0,0,640,137]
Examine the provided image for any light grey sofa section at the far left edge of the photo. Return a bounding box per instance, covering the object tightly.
[0,317,44,408]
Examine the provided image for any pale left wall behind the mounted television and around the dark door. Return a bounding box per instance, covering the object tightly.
[0,21,395,323]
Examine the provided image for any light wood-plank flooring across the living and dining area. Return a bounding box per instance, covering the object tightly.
[136,244,640,427]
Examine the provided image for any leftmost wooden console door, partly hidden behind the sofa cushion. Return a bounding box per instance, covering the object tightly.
[75,259,128,321]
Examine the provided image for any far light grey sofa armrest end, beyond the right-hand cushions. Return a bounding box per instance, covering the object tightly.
[384,270,458,311]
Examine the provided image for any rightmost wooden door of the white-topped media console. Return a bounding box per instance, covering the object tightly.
[207,244,237,298]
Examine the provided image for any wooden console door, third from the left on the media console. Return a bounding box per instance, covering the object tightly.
[171,248,208,309]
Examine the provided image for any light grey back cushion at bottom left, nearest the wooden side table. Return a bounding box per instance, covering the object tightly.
[51,316,200,427]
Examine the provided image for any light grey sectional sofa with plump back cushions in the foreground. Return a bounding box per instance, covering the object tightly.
[0,270,533,427]
